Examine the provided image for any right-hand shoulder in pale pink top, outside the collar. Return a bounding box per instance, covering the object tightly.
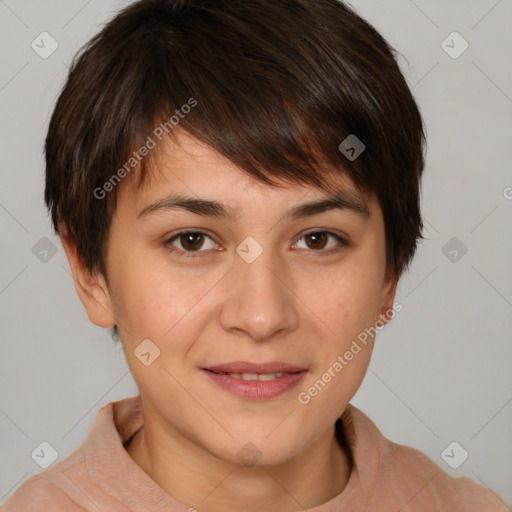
[342,405,510,512]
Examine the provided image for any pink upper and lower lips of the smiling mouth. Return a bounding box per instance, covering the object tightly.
[202,361,308,400]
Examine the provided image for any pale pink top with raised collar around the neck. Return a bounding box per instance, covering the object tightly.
[0,396,510,512]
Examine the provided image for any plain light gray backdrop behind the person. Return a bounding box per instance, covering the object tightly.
[0,0,512,503]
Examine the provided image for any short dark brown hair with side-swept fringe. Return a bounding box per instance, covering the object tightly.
[45,0,425,277]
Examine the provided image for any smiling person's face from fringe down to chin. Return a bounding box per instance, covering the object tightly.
[67,134,396,464]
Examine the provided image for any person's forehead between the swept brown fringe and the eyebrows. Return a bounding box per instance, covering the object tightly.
[118,131,378,220]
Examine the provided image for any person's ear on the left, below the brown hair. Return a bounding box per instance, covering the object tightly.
[59,227,116,327]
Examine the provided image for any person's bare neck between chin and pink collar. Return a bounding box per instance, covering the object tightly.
[127,406,351,512]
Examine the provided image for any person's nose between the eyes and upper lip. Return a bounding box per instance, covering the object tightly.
[220,245,299,342]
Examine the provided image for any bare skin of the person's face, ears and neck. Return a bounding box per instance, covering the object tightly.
[61,133,397,512]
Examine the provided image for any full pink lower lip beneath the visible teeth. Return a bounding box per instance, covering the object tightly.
[203,370,307,400]
